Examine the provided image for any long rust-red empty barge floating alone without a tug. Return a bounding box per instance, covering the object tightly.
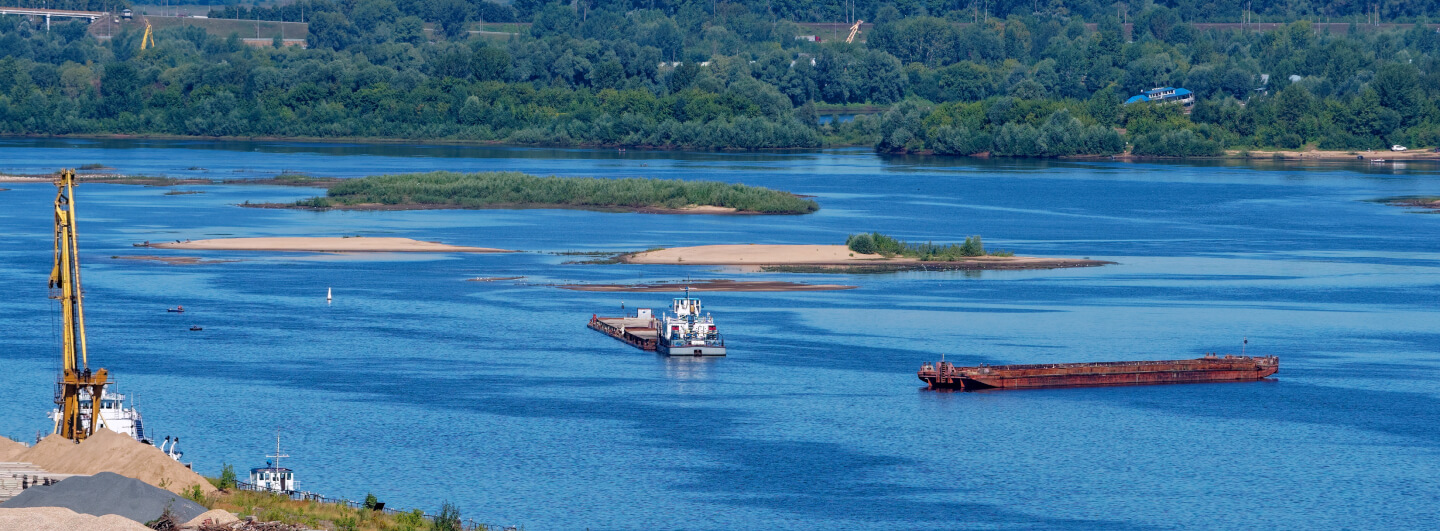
[917,354,1280,390]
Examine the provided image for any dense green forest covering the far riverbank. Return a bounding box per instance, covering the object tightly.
[0,0,1440,157]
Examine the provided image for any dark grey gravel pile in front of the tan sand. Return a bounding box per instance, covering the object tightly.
[0,472,204,522]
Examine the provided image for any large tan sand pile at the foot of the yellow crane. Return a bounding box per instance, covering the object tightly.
[13,429,215,494]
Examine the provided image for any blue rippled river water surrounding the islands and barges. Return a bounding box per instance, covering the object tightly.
[0,140,1440,530]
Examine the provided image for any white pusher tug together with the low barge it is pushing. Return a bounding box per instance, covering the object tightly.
[589,288,726,357]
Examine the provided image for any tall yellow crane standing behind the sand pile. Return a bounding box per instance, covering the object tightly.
[50,170,109,440]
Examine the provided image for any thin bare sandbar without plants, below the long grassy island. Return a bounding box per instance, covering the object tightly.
[137,236,513,253]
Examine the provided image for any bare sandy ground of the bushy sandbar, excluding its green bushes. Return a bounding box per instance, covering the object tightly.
[618,245,1115,271]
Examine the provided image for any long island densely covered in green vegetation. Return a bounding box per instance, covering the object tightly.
[285,171,819,214]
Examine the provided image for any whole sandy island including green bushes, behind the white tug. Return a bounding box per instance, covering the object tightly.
[613,233,1115,273]
